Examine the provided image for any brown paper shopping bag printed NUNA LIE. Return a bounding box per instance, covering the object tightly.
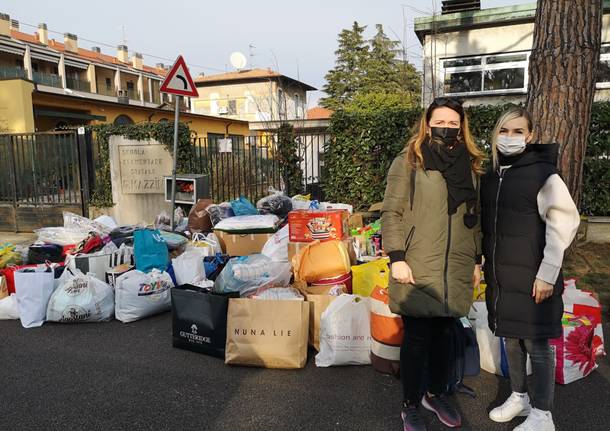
[225,298,309,369]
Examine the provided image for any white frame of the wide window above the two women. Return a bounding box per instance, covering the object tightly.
[439,51,530,96]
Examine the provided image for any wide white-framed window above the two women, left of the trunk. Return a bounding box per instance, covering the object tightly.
[436,52,529,95]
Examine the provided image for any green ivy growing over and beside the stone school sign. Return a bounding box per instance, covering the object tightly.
[89,121,193,207]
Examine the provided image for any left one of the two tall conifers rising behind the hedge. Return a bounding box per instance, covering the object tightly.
[320,21,369,110]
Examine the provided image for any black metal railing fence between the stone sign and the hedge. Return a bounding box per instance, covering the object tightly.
[190,133,330,202]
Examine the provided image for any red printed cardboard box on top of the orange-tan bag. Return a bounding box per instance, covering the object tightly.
[288,210,349,242]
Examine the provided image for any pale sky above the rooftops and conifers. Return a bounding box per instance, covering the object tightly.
[0,0,530,107]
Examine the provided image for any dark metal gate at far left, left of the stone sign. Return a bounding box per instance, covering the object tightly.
[0,130,89,232]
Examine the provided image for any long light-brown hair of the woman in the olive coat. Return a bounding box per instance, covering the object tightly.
[406,104,486,175]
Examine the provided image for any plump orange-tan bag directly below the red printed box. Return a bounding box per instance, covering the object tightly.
[292,240,351,283]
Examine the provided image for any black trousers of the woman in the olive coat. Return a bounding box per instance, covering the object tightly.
[400,316,455,406]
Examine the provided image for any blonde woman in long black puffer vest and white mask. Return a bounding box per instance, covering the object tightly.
[481,108,580,431]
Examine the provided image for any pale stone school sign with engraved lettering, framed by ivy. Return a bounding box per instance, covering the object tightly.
[108,136,172,224]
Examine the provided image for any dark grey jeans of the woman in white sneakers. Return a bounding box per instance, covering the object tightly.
[506,338,555,411]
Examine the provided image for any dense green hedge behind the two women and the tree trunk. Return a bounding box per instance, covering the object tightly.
[324,101,610,216]
